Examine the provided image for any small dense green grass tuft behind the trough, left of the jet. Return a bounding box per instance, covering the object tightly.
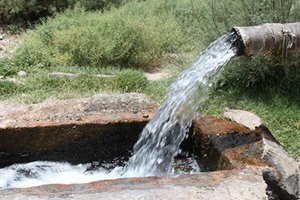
[113,70,149,92]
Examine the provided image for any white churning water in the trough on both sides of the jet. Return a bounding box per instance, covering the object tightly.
[0,157,200,190]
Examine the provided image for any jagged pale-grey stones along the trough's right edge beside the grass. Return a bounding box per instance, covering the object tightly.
[224,110,300,200]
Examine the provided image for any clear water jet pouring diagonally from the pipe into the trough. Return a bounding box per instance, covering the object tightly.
[124,33,236,177]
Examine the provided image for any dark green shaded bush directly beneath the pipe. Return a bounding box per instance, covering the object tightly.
[217,53,300,97]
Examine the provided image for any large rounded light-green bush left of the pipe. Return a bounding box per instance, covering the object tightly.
[14,6,181,68]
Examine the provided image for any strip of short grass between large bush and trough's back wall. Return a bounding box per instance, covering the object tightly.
[0,60,169,103]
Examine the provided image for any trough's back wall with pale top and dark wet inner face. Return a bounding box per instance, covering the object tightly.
[0,93,157,167]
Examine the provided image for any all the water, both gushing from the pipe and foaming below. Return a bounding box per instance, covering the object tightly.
[0,34,236,188]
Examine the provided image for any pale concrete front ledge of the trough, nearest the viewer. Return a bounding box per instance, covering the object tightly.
[0,169,267,200]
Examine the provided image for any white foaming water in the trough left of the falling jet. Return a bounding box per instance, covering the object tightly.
[0,161,122,189]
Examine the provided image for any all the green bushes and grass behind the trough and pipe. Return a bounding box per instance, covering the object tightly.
[0,0,300,158]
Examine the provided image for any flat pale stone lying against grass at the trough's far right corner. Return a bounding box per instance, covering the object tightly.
[224,109,262,130]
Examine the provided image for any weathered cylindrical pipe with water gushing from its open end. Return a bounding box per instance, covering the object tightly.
[232,22,300,57]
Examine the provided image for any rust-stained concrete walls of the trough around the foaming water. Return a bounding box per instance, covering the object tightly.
[0,94,299,200]
